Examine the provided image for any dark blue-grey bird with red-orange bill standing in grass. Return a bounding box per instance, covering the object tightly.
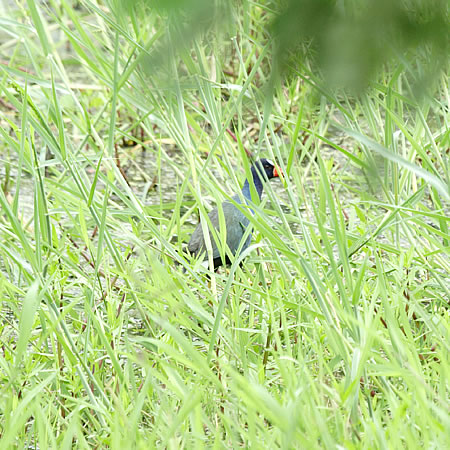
[188,158,282,271]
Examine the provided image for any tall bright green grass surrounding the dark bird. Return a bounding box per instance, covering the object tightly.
[0,0,450,448]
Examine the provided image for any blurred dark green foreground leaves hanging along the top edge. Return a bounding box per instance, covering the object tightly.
[119,0,449,91]
